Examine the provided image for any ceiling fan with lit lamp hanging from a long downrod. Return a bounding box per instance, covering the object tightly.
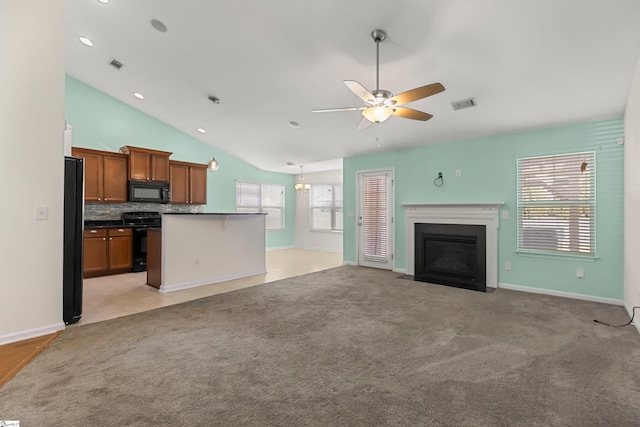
[312,29,444,129]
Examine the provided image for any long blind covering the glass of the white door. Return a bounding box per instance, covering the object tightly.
[362,176,389,259]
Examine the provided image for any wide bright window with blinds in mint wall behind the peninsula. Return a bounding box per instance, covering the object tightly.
[236,181,284,231]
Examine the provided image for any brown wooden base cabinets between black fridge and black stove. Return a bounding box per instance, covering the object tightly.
[83,227,133,277]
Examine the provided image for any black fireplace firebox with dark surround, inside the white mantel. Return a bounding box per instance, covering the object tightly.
[414,223,487,292]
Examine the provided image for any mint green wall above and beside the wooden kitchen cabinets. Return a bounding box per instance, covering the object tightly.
[65,76,295,247]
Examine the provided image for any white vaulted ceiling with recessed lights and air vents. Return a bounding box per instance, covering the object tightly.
[65,0,640,174]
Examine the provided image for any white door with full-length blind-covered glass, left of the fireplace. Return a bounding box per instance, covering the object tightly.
[358,170,393,270]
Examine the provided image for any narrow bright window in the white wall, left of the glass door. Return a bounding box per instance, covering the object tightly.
[309,184,343,231]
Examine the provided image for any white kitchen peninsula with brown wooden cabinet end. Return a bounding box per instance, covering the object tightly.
[147,213,267,292]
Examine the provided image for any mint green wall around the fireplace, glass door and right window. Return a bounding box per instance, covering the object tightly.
[343,119,623,300]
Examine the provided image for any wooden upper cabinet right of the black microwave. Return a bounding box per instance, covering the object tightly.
[169,160,207,205]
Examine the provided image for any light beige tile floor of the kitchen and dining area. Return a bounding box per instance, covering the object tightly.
[71,249,342,327]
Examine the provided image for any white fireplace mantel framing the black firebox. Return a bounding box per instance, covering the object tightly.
[402,203,503,288]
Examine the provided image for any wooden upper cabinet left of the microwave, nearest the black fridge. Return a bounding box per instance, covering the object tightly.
[71,147,127,203]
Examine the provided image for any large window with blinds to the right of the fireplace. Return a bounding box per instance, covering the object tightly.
[518,152,596,256]
